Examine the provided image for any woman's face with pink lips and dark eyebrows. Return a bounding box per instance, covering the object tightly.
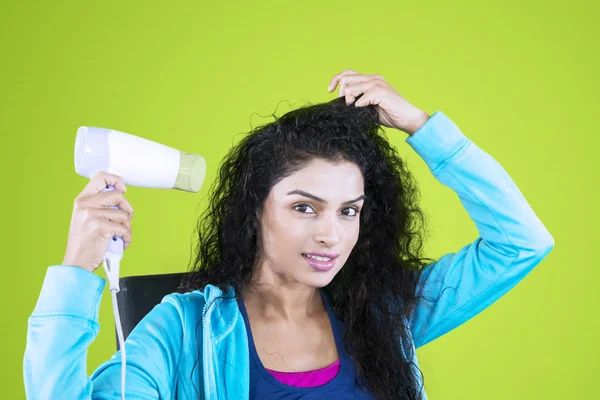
[257,159,364,287]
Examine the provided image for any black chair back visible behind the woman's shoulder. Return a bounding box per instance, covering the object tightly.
[115,272,187,350]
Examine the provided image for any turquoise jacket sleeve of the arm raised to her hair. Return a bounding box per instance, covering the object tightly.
[406,111,554,348]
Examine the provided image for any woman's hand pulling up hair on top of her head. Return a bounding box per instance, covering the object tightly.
[328,69,430,136]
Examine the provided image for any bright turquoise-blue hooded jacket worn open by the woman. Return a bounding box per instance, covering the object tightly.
[23,111,554,400]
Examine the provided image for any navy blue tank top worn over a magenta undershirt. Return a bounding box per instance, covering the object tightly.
[237,290,373,400]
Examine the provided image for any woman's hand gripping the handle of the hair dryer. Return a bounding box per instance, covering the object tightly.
[62,172,133,272]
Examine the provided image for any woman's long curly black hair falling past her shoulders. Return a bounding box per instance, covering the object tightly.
[179,97,435,400]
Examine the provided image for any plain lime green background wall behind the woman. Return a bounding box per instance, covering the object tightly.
[0,0,600,400]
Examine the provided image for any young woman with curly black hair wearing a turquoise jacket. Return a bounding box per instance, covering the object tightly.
[24,70,554,400]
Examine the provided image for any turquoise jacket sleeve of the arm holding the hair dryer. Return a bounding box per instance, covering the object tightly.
[23,265,182,400]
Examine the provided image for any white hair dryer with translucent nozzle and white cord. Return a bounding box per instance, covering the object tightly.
[75,126,206,399]
